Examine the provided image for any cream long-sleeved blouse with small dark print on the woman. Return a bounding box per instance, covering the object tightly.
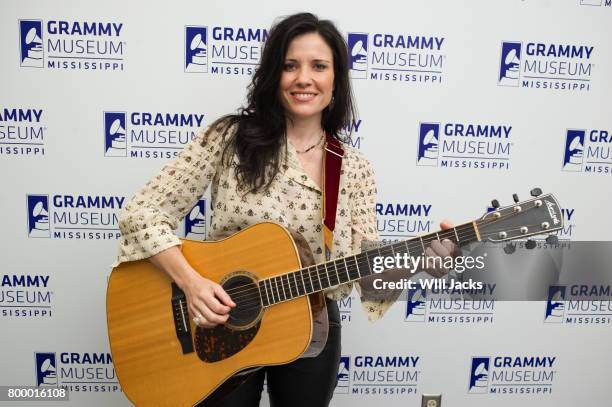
[116,124,393,321]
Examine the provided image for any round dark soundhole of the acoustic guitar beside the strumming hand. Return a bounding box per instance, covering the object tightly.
[221,274,262,329]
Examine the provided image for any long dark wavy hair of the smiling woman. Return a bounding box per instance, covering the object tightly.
[211,13,356,192]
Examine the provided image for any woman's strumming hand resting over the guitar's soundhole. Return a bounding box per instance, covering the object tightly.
[181,272,236,328]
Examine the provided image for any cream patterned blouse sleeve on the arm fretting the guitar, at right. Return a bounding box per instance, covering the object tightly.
[351,156,399,322]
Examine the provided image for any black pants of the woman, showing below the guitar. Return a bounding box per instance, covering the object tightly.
[206,300,341,407]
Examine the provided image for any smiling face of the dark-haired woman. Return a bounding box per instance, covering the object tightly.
[279,33,334,121]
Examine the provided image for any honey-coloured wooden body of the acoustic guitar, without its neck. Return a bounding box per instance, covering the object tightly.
[106,223,328,406]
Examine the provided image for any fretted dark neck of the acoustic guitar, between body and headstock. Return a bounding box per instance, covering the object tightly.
[259,222,480,307]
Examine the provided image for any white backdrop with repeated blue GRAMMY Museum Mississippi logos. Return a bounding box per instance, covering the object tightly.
[0,0,612,407]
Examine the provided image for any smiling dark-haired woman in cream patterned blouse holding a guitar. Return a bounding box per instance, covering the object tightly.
[119,13,456,407]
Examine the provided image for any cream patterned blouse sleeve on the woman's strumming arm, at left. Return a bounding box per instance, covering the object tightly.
[114,125,227,265]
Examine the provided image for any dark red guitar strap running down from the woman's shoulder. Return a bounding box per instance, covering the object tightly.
[321,134,344,260]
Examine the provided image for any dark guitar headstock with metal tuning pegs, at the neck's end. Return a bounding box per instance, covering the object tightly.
[476,188,563,242]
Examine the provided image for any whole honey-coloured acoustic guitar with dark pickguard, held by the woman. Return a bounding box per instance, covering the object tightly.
[106,188,563,406]
